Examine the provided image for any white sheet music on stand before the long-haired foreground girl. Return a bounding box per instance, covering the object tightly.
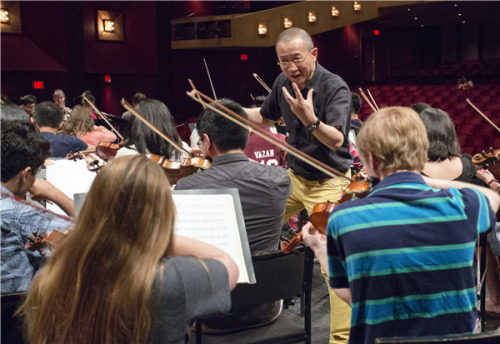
[173,194,249,283]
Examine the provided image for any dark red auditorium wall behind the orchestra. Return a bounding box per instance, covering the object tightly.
[1,1,498,123]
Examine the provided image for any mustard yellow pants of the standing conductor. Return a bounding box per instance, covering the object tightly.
[283,169,351,344]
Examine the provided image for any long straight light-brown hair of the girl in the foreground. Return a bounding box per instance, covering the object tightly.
[21,155,175,344]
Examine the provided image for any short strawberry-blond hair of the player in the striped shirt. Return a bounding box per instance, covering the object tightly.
[356,106,429,175]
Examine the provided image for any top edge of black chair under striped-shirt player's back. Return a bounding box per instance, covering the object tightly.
[375,329,500,344]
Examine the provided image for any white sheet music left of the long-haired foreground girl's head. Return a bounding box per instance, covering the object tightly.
[46,159,96,214]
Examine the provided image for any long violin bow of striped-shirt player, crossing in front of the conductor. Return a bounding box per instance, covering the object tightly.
[186,90,353,181]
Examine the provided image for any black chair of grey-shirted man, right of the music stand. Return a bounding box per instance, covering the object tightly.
[191,246,314,344]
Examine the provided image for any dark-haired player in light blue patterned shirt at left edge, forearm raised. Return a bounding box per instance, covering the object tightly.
[0,120,74,293]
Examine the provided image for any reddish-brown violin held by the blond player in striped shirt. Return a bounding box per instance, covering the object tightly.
[281,173,374,254]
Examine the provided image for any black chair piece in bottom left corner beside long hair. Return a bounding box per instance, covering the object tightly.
[1,293,26,344]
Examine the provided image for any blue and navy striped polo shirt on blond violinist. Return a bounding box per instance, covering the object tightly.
[327,172,495,344]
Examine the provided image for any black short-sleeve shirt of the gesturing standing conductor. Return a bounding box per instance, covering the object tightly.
[260,62,352,180]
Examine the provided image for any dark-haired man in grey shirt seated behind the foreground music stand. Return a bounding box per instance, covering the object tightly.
[175,99,292,331]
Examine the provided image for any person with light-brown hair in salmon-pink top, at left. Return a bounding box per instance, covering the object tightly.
[61,105,116,149]
